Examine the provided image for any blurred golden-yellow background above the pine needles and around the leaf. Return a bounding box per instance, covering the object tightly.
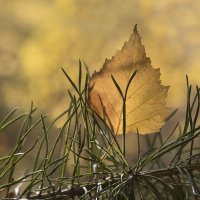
[0,0,200,158]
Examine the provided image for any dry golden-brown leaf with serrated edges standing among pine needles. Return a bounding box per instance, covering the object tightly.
[89,26,169,134]
